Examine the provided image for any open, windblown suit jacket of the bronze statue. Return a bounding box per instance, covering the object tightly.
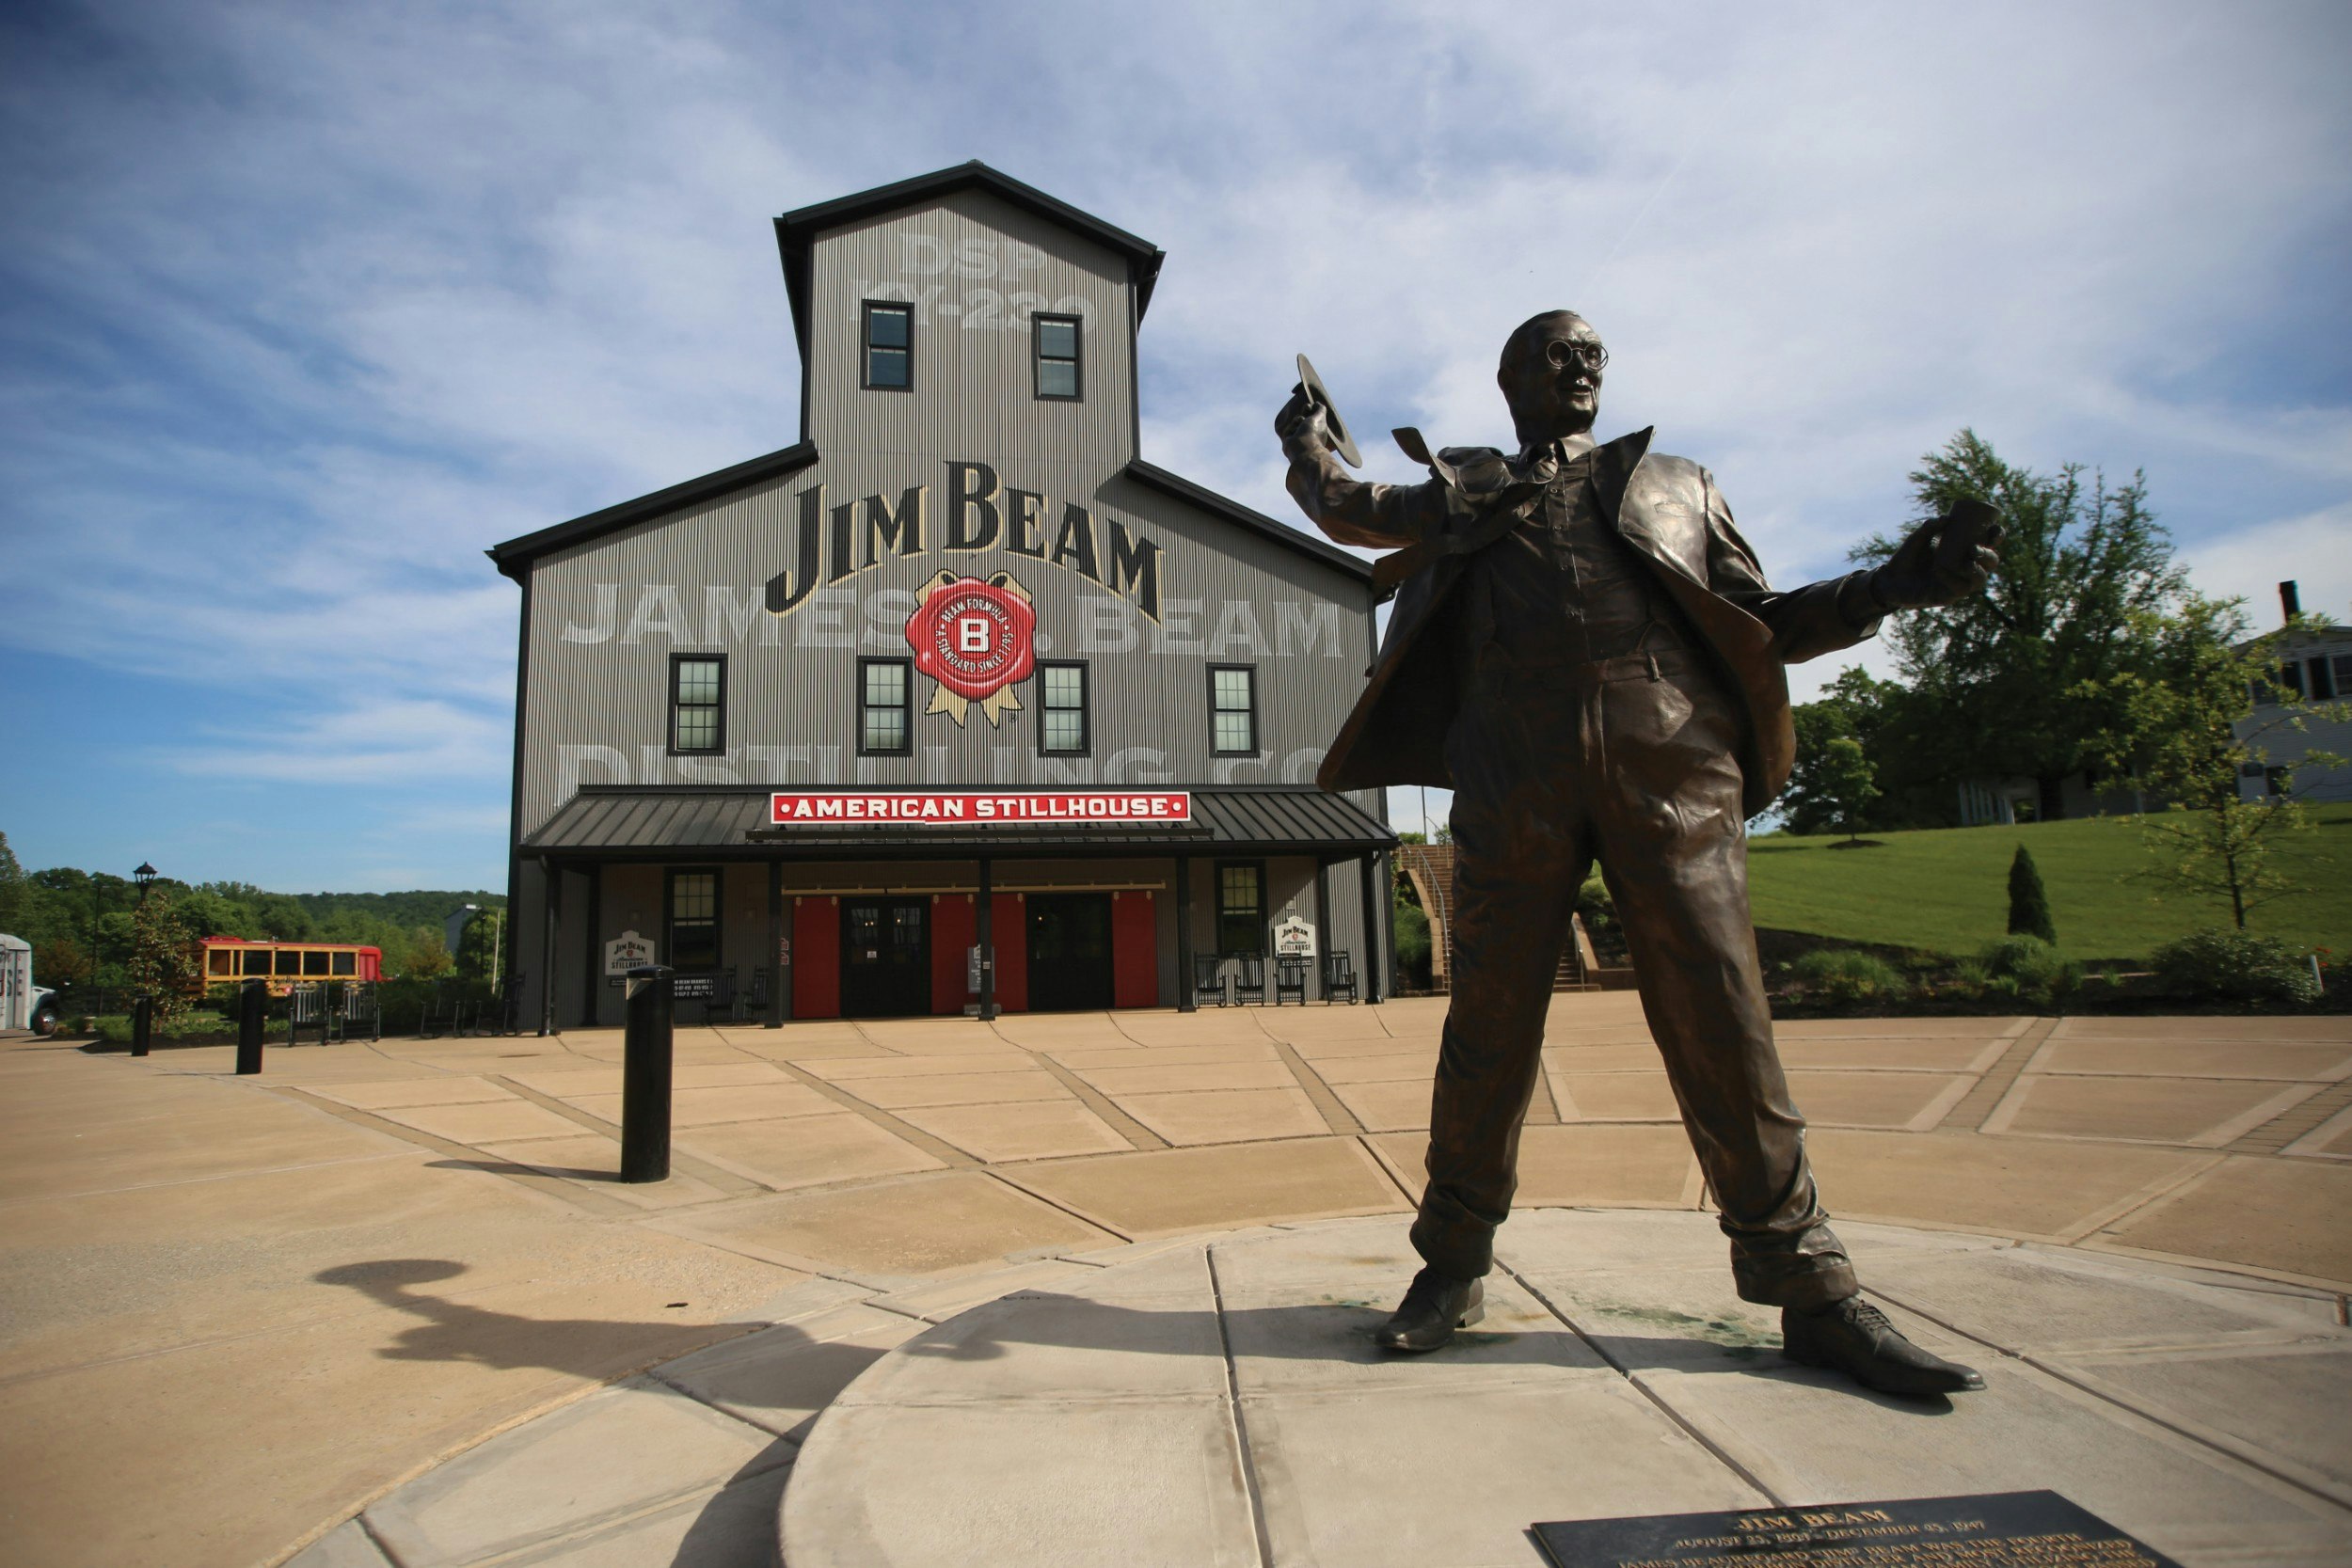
[1294,430,1877,816]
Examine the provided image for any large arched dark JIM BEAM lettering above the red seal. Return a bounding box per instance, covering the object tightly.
[767,461,1162,623]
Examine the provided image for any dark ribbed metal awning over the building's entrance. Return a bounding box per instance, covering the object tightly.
[522,785,1397,861]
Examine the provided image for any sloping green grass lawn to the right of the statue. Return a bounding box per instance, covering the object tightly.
[1748,806,2352,959]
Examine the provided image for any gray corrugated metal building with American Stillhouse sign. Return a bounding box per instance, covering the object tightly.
[489,162,1395,1027]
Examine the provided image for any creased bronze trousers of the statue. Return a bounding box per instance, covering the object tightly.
[1414,649,1856,1307]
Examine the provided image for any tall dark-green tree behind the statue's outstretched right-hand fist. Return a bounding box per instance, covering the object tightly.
[1853,430,2187,820]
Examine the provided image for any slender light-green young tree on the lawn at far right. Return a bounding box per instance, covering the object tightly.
[2101,594,2347,931]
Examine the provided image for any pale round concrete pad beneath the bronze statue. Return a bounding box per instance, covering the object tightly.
[781,1211,2352,1568]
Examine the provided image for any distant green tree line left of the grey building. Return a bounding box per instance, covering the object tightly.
[0,832,506,988]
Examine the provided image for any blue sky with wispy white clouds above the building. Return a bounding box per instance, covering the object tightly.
[0,0,2352,889]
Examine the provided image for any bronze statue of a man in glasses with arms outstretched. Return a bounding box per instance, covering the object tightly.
[1275,310,1999,1394]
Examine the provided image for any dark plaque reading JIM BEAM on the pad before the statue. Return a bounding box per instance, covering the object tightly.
[1536,1493,2181,1568]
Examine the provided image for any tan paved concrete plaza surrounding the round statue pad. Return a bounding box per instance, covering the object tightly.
[0,994,2352,1568]
